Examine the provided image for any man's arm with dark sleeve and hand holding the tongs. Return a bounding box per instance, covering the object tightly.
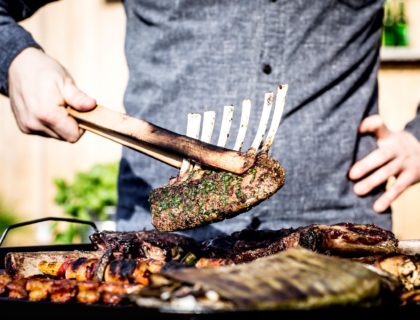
[0,0,96,142]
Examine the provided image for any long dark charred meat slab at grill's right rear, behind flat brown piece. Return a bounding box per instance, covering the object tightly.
[200,223,398,263]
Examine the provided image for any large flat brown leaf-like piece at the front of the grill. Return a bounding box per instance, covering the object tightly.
[136,249,388,310]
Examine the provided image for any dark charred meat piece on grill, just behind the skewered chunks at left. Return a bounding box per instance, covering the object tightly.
[90,230,195,261]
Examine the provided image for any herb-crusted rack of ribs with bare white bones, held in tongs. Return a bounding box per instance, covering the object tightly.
[149,85,287,231]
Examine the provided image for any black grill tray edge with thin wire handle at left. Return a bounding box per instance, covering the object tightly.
[0,217,420,320]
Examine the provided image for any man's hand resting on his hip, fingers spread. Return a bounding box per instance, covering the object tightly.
[349,115,420,212]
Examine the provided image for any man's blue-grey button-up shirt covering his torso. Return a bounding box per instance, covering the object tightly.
[0,0,419,238]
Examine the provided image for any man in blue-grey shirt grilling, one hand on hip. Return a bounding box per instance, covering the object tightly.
[0,0,420,238]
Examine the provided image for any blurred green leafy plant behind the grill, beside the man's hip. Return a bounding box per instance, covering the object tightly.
[52,163,118,243]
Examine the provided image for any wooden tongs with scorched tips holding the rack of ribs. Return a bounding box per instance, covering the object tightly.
[67,106,255,174]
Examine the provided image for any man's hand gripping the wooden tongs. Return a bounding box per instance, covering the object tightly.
[9,48,96,142]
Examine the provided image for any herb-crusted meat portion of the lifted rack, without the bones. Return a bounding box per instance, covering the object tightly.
[149,152,285,231]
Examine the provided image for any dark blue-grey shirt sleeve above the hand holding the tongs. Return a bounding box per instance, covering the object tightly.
[0,0,55,95]
